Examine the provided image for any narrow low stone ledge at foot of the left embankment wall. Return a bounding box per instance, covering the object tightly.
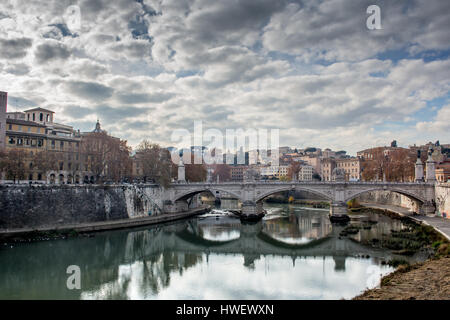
[0,206,211,242]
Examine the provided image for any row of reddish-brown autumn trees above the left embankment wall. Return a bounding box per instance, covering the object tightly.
[0,132,213,187]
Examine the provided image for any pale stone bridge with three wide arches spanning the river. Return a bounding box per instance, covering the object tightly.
[160,181,435,216]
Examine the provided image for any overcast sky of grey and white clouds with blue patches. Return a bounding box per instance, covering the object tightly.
[0,0,450,153]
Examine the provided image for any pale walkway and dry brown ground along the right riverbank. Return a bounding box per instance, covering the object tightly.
[353,203,450,300]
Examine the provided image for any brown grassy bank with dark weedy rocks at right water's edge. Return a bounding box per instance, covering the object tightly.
[352,208,450,300]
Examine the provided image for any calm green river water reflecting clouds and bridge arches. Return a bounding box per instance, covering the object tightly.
[0,201,428,299]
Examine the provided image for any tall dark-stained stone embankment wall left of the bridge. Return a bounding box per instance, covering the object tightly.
[0,185,162,230]
